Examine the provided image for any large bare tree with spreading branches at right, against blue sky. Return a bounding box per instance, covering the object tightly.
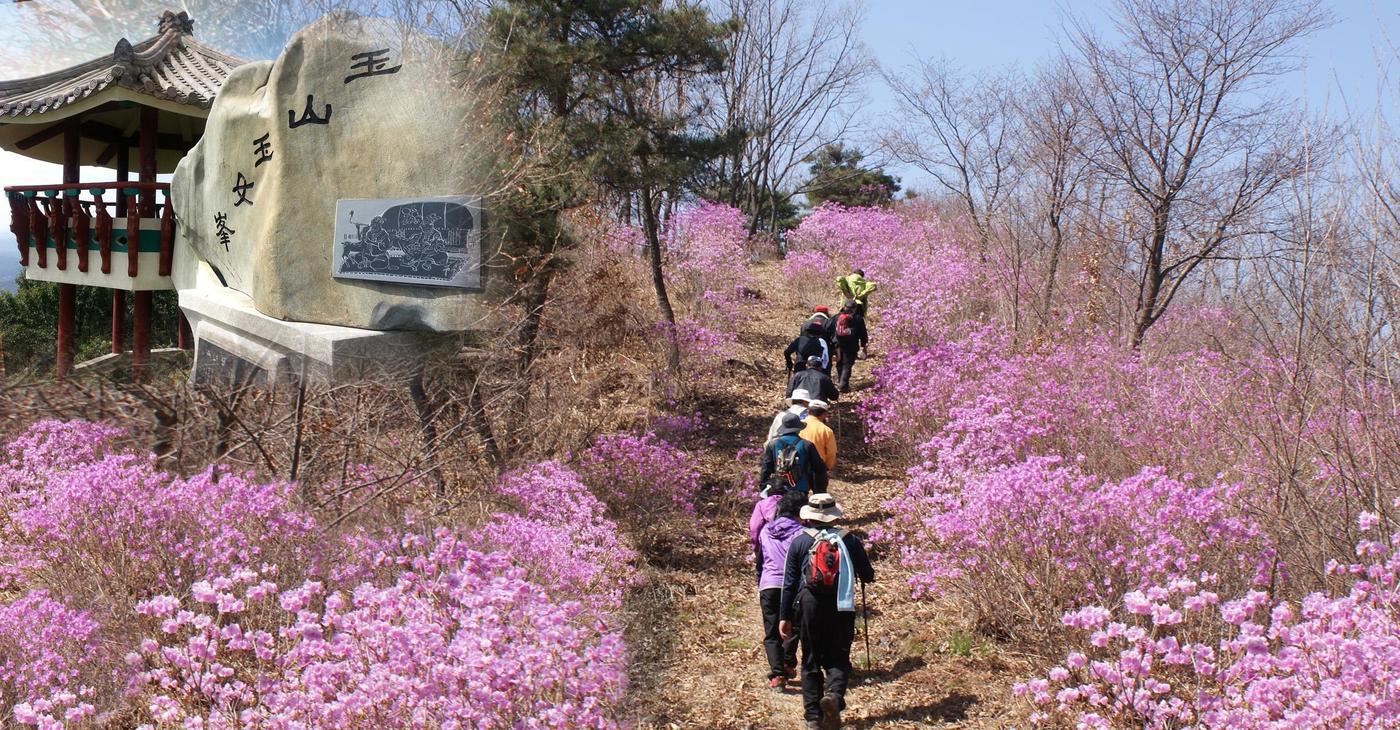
[1068,0,1329,346]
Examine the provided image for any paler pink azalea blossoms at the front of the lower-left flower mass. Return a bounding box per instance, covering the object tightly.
[127,531,626,729]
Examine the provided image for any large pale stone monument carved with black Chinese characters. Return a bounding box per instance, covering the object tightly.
[171,14,489,383]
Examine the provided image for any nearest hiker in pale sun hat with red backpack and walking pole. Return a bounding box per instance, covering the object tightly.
[778,495,875,729]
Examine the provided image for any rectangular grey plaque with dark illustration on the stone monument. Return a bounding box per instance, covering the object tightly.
[330,198,482,289]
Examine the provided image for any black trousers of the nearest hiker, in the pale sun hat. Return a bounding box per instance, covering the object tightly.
[797,588,855,720]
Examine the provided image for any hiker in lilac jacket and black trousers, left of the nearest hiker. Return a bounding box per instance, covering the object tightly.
[749,492,806,691]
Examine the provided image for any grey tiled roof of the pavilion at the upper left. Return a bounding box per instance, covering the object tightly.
[0,11,244,118]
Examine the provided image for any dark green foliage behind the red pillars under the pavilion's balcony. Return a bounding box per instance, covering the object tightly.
[0,277,179,376]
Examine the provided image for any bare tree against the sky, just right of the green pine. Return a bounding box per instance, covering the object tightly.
[710,0,874,233]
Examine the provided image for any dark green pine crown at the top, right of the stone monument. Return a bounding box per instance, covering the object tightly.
[487,0,738,209]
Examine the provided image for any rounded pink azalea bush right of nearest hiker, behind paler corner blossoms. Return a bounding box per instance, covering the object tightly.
[883,457,1273,642]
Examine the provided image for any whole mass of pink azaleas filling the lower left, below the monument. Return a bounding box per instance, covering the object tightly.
[0,422,636,727]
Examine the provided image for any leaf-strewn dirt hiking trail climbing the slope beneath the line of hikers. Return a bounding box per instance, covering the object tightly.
[629,263,1018,730]
